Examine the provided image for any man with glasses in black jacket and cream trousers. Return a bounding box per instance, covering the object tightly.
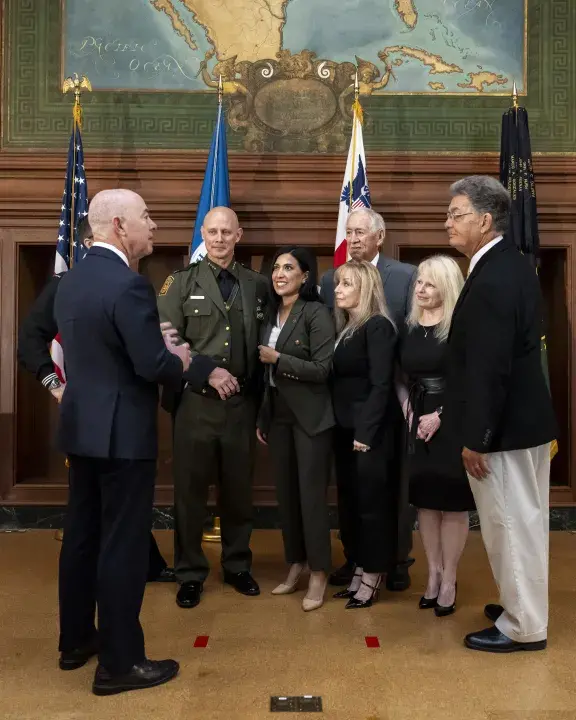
[442,176,556,653]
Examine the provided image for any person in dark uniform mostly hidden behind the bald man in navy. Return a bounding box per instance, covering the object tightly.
[18,217,176,582]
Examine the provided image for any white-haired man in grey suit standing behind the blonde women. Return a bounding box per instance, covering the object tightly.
[320,208,416,590]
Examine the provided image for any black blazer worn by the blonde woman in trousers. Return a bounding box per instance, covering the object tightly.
[332,315,397,446]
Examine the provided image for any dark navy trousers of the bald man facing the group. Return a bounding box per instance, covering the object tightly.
[59,455,156,674]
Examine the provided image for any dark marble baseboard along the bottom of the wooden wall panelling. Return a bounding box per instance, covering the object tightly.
[0,505,576,532]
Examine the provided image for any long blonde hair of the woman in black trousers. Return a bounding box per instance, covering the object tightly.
[334,260,396,340]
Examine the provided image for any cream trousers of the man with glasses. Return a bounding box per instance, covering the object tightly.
[468,443,550,642]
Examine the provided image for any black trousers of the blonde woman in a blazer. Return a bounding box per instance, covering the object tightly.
[334,427,398,573]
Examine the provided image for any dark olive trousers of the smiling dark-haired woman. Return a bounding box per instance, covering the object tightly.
[268,393,332,573]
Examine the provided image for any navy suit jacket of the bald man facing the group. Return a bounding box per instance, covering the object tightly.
[54,247,182,460]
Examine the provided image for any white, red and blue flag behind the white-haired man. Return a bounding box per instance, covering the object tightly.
[334,100,371,268]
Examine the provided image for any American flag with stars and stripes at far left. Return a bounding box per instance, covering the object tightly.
[50,122,88,382]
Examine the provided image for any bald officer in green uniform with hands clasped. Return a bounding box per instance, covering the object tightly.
[158,207,267,608]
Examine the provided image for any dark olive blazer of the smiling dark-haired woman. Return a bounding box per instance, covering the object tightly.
[258,300,335,436]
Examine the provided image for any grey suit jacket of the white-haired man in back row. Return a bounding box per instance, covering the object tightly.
[320,253,417,328]
